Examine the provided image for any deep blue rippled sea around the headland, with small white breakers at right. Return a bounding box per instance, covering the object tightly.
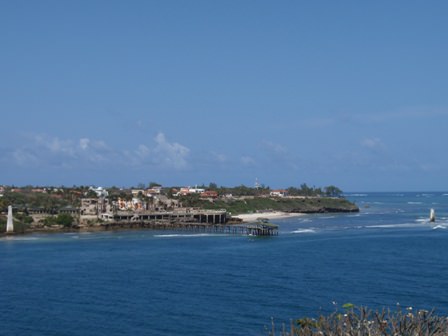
[0,192,448,336]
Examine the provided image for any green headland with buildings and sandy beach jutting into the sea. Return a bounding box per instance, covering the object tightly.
[0,182,359,236]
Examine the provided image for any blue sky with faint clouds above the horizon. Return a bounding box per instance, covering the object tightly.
[0,0,448,191]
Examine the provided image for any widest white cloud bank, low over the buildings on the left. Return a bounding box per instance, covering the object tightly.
[6,132,190,170]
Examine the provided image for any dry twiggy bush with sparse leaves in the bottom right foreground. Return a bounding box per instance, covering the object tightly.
[269,304,448,336]
